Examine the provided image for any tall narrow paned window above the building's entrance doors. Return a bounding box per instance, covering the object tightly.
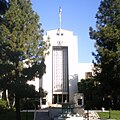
[52,46,69,101]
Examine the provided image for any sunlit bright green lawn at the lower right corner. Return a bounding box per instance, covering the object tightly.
[98,110,120,120]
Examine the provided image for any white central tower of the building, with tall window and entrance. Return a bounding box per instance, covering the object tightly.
[41,29,78,105]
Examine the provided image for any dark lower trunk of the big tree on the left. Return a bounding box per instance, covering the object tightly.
[15,95,21,120]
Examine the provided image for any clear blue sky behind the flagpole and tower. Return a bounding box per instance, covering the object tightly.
[31,0,101,63]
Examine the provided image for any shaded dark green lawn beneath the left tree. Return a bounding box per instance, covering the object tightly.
[0,112,34,120]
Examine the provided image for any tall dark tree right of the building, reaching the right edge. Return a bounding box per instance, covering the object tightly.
[90,0,120,107]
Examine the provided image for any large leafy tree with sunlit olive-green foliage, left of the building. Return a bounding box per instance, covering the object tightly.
[0,0,49,120]
